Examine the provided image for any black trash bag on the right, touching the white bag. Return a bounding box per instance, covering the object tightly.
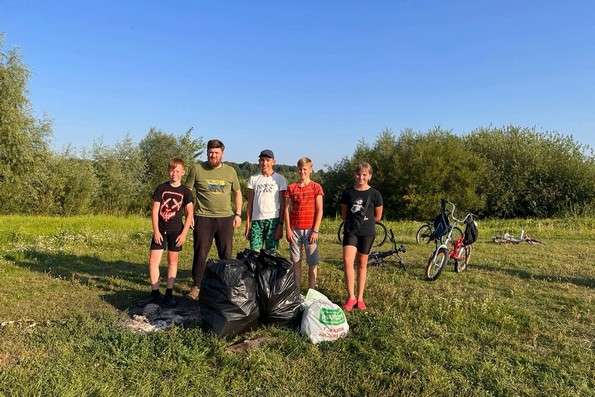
[256,250,302,327]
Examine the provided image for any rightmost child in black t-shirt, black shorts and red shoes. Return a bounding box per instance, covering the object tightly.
[341,163,382,312]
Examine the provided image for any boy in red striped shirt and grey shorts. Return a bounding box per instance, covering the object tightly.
[284,157,324,288]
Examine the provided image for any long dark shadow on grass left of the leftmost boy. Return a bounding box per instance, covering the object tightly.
[7,250,190,310]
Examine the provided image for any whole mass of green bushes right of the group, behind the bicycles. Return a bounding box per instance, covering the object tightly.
[321,126,595,219]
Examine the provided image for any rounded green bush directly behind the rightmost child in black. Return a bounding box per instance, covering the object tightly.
[323,128,485,219]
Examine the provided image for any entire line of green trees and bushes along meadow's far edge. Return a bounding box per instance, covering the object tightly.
[0,35,595,219]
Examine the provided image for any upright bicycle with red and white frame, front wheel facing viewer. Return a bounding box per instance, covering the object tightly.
[426,201,476,281]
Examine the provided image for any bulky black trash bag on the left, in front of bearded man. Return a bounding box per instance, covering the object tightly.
[198,259,259,336]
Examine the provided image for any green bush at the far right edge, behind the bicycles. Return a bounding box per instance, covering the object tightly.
[466,126,595,218]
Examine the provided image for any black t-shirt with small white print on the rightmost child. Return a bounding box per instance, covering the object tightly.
[341,187,382,236]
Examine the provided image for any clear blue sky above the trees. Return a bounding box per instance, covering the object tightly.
[0,0,595,166]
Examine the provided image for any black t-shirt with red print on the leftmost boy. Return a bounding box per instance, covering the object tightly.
[153,182,192,233]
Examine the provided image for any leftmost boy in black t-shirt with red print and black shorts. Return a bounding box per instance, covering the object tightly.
[149,159,194,306]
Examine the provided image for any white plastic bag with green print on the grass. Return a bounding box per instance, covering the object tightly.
[301,289,349,343]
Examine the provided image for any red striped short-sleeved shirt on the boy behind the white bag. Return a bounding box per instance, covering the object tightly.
[285,181,324,229]
